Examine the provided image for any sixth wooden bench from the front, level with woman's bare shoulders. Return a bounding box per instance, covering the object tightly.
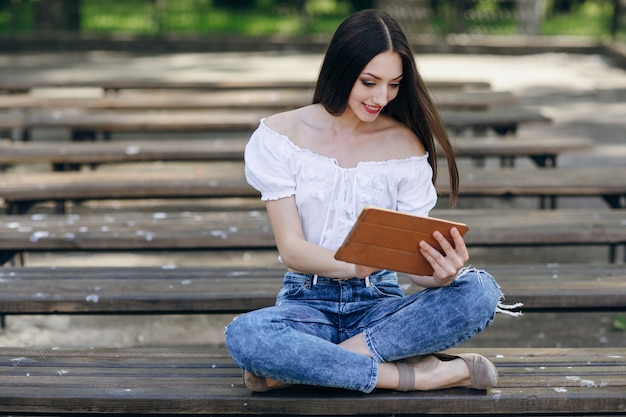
[0,106,550,141]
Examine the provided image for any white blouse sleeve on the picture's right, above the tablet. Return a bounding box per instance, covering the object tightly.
[396,157,437,216]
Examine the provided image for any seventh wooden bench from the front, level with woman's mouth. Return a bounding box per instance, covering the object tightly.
[0,88,519,111]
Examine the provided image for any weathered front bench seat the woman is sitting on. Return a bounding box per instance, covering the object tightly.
[0,346,626,416]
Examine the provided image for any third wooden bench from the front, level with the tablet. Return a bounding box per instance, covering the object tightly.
[0,209,626,264]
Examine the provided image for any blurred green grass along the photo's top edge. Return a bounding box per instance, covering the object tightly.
[0,0,626,39]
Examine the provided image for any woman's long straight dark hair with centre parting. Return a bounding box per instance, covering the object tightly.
[313,9,459,205]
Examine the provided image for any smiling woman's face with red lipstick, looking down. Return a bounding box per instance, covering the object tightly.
[348,51,402,122]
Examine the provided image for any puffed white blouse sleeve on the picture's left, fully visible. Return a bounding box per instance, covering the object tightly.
[244,121,296,201]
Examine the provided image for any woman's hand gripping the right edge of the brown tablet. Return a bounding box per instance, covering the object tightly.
[420,227,469,286]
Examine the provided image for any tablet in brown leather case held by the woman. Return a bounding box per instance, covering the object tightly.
[335,207,469,276]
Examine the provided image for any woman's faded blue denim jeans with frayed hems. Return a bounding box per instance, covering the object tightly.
[226,269,501,393]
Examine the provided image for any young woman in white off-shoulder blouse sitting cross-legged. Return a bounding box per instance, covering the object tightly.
[226,10,508,393]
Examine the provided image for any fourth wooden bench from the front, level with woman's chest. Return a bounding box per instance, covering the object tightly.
[0,162,626,214]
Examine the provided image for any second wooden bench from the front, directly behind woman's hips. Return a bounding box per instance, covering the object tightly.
[0,264,626,315]
